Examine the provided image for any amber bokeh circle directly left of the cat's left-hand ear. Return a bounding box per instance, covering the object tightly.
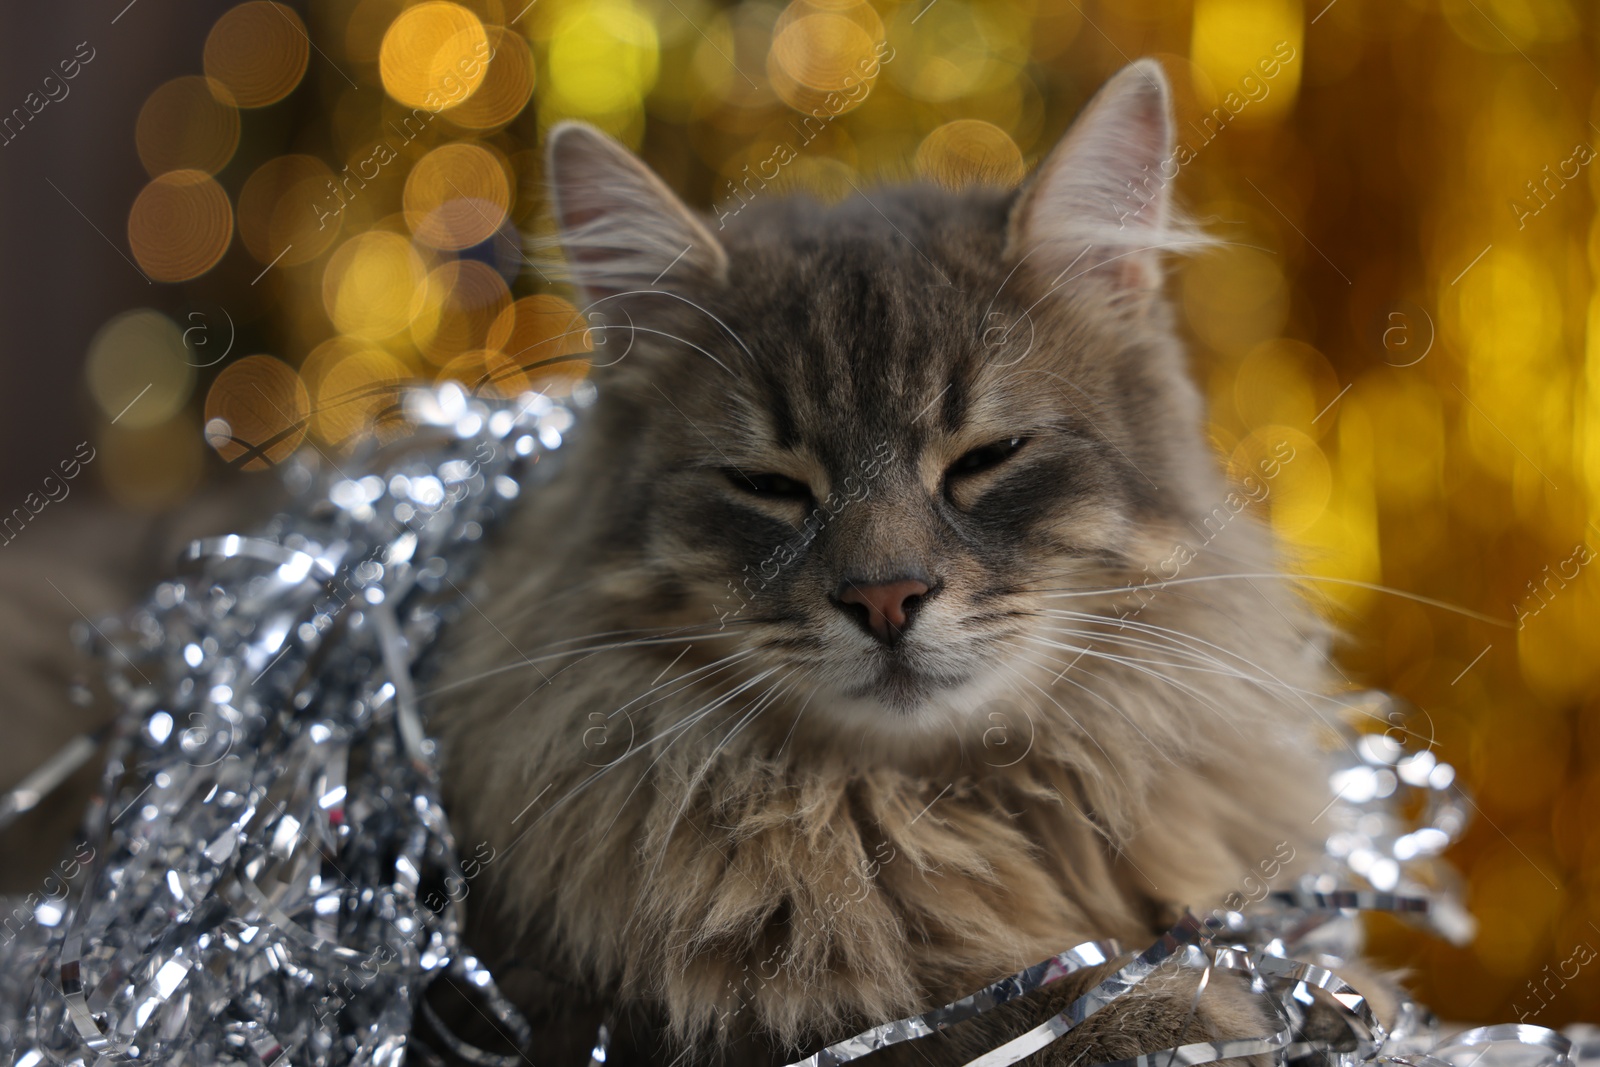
[403,142,510,251]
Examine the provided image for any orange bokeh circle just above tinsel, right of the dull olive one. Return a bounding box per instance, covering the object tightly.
[205,355,310,470]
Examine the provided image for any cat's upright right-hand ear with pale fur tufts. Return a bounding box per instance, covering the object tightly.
[1008,59,1203,299]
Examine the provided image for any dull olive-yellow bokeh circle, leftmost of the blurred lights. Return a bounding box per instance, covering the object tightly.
[85,307,195,429]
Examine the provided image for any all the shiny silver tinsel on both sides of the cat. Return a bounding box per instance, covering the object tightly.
[0,384,1600,1067]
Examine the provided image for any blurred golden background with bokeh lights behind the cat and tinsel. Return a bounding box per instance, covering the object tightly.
[0,0,1600,1025]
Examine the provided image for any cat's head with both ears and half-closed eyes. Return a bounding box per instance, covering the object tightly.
[549,61,1221,735]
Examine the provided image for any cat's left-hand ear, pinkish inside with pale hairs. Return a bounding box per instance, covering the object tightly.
[546,122,728,304]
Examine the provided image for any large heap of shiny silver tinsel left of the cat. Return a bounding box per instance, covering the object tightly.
[0,384,582,1067]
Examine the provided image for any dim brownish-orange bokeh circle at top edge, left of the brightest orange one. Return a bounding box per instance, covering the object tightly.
[205,0,310,107]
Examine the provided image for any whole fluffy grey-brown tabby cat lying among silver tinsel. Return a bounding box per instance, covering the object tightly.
[429,61,1363,1064]
